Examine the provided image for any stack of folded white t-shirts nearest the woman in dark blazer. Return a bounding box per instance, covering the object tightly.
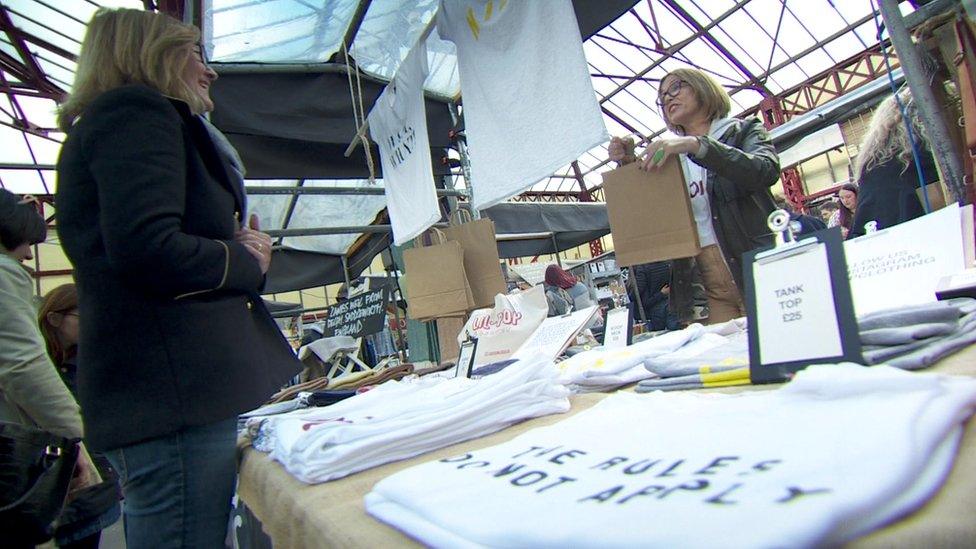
[248,360,569,483]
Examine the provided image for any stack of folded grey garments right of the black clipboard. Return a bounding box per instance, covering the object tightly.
[857,297,976,370]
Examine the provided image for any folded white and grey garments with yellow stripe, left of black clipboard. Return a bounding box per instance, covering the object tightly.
[635,331,749,393]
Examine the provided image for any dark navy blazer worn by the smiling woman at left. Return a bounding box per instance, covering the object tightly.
[56,85,301,450]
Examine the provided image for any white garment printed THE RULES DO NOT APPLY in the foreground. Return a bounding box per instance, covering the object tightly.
[365,364,976,548]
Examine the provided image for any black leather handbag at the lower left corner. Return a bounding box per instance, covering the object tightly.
[0,422,78,546]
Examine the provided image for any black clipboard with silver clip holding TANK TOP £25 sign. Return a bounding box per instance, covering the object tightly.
[743,228,861,383]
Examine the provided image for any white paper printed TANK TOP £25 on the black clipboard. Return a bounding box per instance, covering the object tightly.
[752,243,843,364]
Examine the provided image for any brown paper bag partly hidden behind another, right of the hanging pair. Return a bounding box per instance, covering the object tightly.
[443,210,508,308]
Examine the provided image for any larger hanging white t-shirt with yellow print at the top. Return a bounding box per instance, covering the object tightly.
[437,0,609,209]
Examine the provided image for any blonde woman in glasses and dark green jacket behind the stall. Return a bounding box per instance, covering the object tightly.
[609,69,779,323]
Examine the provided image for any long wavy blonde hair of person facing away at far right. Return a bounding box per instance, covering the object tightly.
[854,90,928,181]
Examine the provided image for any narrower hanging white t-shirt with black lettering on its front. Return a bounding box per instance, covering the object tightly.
[368,44,441,245]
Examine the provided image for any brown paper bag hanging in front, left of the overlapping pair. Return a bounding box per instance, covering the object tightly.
[403,229,475,320]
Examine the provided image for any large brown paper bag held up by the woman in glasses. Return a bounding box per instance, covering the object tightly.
[603,156,701,267]
